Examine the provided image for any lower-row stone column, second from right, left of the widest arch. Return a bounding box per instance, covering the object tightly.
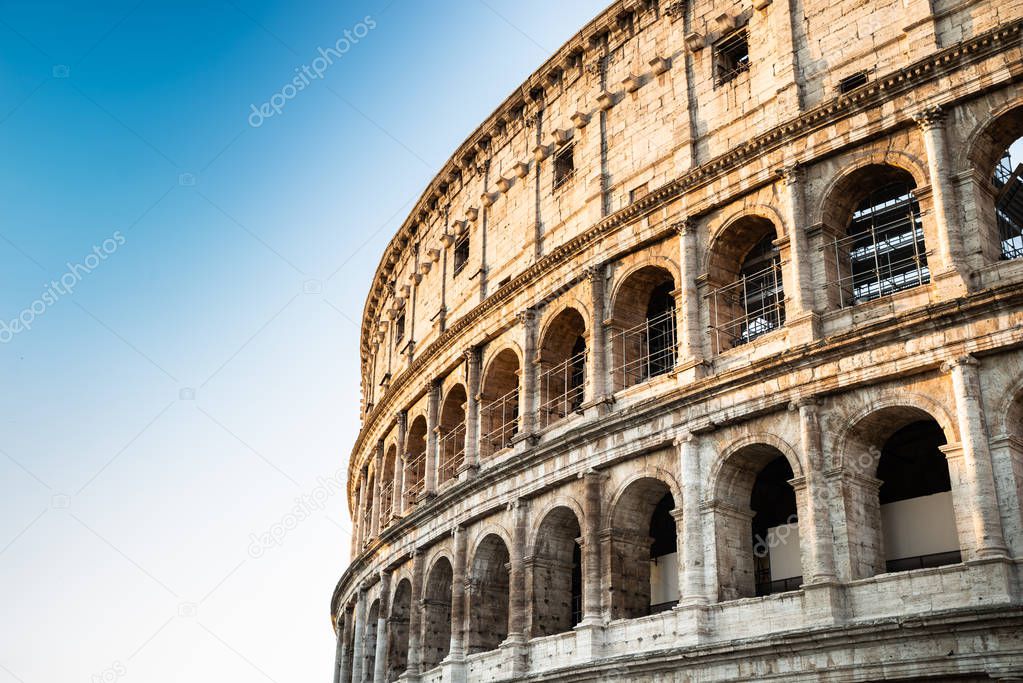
[789,398,835,584]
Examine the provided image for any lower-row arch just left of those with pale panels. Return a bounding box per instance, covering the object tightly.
[532,507,582,637]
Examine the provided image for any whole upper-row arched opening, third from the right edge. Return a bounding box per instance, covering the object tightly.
[708,216,785,352]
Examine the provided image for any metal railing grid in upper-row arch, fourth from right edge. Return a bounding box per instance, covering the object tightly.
[611,309,677,389]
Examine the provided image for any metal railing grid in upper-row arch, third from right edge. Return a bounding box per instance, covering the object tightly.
[710,261,785,351]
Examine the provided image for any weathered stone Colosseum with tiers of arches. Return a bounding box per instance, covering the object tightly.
[330,0,1023,683]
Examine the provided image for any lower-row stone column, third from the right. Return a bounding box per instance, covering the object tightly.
[675,432,710,605]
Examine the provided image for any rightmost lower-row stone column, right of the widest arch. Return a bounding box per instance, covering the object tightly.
[942,356,1007,557]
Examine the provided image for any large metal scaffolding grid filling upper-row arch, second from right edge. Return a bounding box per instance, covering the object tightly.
[831,190,931,306]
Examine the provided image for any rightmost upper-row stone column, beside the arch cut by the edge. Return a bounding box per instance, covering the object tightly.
[914,106,965,289]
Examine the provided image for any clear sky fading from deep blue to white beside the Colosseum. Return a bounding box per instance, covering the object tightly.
[0,0,606,683]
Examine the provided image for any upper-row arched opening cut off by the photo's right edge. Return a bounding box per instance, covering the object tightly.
[964,106,1023,261]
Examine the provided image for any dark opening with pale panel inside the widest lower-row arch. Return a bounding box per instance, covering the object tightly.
[877,419,962,572]
